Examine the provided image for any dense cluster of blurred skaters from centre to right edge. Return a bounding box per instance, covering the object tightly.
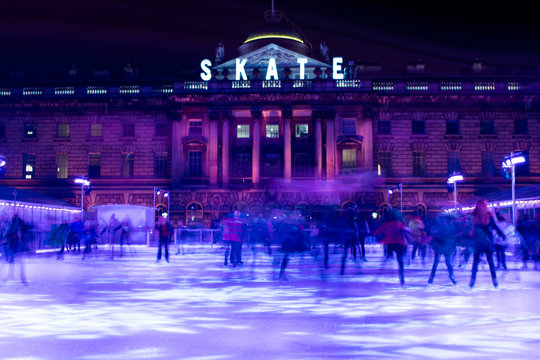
[211,200,540,288]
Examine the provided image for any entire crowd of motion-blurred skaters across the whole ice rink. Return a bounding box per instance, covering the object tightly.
[0,200,540,288]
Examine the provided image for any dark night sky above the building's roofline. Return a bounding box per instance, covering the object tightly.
[0,0,540,78]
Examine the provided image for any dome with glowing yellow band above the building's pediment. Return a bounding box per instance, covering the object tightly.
[238,11,311,56]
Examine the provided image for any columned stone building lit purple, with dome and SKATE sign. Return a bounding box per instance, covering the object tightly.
[0,12,540,223]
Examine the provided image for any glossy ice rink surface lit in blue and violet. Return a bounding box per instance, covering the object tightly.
[0,243,540,360]
